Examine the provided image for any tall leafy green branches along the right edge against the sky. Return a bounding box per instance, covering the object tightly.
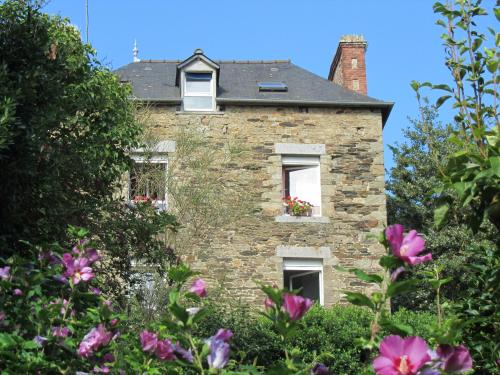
[412,0,500,374]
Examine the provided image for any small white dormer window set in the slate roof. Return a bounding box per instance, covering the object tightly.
[183,72,215,111]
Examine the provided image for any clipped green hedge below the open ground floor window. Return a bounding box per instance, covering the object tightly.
[196,304,434,375]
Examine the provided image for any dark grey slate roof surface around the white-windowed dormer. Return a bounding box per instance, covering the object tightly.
[116,60,393,123]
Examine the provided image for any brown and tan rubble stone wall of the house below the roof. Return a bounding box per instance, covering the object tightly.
[141,106,386,305]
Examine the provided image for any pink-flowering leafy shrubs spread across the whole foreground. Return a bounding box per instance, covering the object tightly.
[0,224,480,375]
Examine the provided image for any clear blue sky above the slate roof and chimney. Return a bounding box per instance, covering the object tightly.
[44,0,468,176]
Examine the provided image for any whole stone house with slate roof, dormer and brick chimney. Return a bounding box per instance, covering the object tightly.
[117,36,393,306]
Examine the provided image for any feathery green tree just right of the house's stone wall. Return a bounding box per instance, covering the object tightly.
[386,105,494,310]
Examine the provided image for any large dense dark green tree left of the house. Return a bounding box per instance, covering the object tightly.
[0,1,140,251]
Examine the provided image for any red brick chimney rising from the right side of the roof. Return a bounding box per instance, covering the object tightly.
[328,35,368,95]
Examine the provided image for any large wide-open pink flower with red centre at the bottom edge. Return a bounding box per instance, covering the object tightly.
[373,335,431,375]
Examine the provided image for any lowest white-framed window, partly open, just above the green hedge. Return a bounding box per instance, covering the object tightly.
[283,258,323,305]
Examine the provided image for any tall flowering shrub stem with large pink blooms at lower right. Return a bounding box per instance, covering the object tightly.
[339,224,472,375]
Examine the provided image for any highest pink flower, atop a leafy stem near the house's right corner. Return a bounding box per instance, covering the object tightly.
[385,224,432,266]
